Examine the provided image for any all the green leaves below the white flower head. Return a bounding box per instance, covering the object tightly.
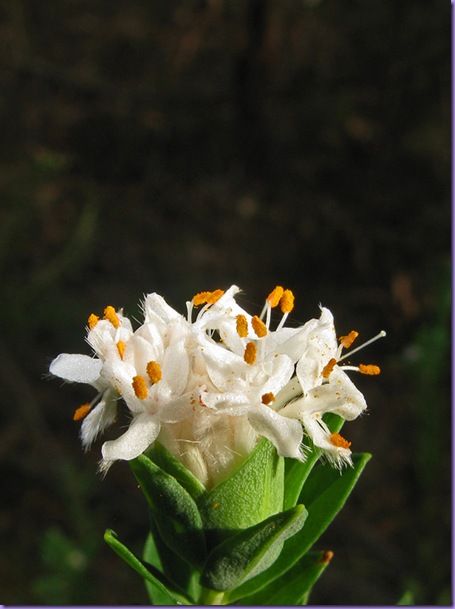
[105,417,370,605]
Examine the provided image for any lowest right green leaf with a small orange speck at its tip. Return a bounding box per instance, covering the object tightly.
[239,552,332,606]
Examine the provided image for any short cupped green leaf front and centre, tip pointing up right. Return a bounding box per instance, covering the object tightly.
[201,505,307,590]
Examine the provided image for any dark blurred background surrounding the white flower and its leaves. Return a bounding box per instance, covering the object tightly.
[0,0,451,605]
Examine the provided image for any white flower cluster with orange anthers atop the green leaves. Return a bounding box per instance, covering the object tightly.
[50,286,384,486]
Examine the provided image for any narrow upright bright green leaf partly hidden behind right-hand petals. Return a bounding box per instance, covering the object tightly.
[283,413,344,510]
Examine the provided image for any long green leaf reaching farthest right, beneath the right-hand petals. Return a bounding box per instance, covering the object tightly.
[229,453,371,602]
